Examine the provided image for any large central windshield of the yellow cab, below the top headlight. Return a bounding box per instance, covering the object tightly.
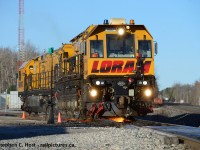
[106,34,135,58]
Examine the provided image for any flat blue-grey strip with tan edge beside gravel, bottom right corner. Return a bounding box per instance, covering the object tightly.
[136,119,200,150]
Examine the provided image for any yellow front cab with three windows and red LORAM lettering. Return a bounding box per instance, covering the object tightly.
[71,18,154,79]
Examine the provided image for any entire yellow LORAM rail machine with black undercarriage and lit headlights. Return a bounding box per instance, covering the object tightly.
[18,19,157,117]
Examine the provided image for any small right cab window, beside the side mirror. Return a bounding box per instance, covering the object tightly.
[138,40,152,58]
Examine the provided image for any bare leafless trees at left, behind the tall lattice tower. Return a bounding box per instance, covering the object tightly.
[0,41,39,93]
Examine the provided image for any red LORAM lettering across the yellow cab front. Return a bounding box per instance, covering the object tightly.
[91,60,151,73]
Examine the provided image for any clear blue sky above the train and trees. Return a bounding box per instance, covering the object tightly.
[0,0,200,89]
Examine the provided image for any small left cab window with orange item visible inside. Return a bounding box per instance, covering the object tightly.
[90,40,104,58]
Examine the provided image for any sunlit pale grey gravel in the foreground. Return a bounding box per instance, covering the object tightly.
[0,126,189,150]
